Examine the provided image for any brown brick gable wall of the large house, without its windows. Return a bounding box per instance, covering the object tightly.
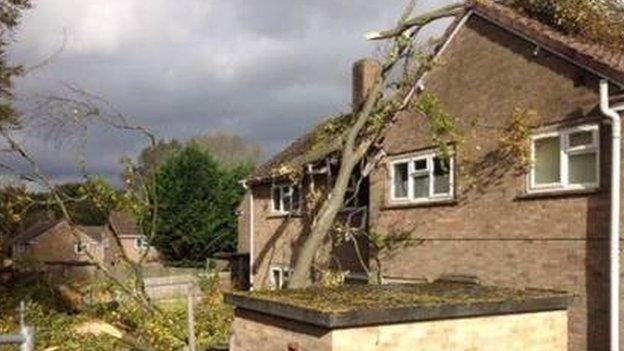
[371,13,624,350]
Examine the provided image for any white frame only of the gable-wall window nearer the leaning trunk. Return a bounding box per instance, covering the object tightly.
[389,151,455,204]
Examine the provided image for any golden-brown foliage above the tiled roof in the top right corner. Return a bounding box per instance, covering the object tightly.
[509,0,624,50]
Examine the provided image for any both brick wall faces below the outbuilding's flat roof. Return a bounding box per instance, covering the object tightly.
[230,311,568,351]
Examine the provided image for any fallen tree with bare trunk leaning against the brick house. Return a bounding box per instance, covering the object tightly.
[285,1,464,288]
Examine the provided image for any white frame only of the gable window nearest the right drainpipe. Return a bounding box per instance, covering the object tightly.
[527,124,600,193]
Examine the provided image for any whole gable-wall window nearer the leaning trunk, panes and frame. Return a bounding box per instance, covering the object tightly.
[390,152,453,202]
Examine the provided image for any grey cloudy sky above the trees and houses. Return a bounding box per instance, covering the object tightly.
[10,0,444,180]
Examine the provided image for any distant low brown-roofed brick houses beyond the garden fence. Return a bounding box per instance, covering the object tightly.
[11,212,159,278]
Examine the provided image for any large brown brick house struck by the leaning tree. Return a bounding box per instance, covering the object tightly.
[238,2,624,350]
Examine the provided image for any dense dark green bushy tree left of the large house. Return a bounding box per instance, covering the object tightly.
[154,143,249,263]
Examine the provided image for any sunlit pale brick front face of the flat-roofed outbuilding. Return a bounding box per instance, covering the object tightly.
[334,311,568,351]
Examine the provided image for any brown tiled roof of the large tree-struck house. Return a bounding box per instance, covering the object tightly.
[248,1,624,182]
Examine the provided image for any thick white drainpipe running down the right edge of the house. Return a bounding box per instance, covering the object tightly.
[600,79,624,351]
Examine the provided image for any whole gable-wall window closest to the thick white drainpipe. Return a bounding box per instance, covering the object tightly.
[529,125,600,191]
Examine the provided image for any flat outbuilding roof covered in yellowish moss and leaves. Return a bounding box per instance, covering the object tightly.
[226,281,572,328]
